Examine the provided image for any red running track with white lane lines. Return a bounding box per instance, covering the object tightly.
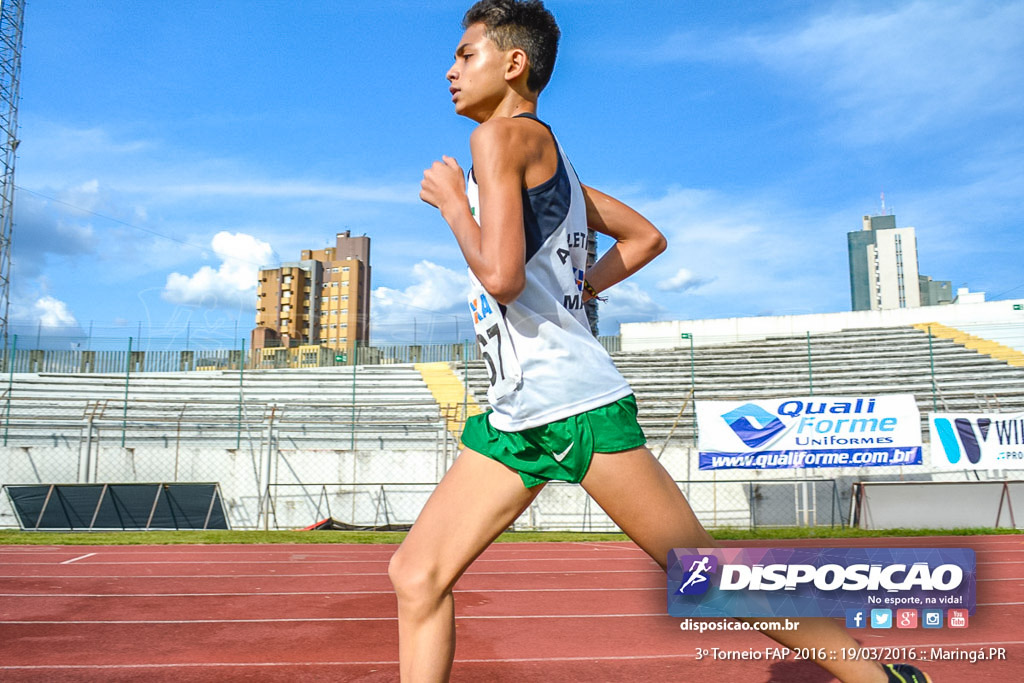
[0,536,1024,683]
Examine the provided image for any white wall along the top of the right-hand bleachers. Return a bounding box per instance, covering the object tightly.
[620,299,1024,351]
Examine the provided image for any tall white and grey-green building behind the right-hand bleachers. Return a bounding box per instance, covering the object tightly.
[847,214,952,310]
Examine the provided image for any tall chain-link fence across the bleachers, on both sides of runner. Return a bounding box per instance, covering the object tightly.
[0,325,1024,531]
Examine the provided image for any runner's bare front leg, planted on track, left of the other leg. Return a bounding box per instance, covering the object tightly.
[388,449,544,683]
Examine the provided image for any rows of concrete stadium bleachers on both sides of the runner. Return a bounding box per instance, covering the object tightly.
[9,327,1024,456]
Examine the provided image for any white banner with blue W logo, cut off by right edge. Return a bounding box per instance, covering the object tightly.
[928,413,1024,470]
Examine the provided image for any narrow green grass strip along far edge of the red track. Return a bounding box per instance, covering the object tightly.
[0,527,1022,546]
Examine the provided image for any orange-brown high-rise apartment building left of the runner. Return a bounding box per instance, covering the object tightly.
[252,230,370,353]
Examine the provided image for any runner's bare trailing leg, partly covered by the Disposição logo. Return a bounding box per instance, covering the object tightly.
[583,447,888,683]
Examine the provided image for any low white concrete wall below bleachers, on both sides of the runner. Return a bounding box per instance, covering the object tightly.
[0,443,1007,531]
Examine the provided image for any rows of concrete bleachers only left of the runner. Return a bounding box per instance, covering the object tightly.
[2,365,444,450]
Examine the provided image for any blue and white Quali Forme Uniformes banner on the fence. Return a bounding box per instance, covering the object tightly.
[696,394,922,470]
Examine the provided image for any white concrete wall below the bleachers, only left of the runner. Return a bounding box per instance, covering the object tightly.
[0,444,451,528]
